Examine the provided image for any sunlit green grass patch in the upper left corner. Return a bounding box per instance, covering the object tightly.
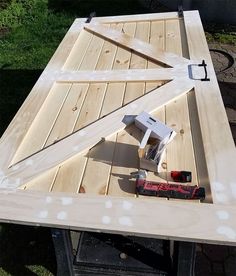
[0,0,75,69]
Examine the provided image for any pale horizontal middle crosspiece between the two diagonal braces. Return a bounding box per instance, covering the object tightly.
[55,65,188,83]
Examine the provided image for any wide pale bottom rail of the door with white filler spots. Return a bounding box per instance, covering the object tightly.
[0,189,236,246]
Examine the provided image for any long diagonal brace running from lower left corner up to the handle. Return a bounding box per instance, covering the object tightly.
[0,78,193,188]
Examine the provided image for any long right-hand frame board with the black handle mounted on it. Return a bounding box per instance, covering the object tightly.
[184,11,236,204]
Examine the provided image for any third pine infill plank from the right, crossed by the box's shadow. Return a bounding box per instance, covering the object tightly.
[108,22,150,196]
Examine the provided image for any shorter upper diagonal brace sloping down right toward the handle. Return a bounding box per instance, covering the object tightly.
[84,23,189,67]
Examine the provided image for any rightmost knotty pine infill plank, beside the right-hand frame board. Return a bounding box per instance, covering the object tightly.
[165,20,198,188]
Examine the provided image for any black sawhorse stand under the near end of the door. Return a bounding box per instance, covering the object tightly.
[52,229,195,276]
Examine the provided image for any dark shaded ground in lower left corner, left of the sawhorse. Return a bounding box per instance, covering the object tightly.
[0,224,56,276]
